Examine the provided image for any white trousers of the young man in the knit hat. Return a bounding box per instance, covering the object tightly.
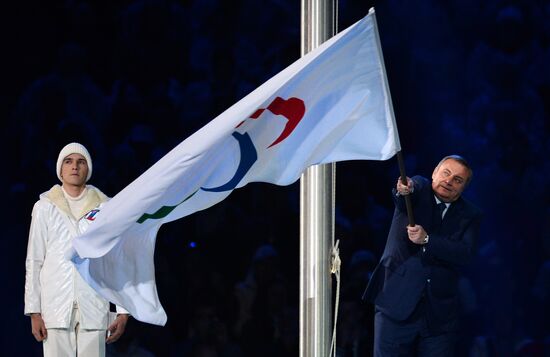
[43,304,106,357]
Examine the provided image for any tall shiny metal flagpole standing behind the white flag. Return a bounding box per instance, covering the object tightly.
[300,0,338,357]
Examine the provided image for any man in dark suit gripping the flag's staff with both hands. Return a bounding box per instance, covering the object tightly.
[364,155,482,357]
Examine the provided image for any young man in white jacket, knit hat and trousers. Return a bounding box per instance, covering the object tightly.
[25,143,129,357]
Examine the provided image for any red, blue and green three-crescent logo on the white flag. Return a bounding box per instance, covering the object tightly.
[137,97,306,223]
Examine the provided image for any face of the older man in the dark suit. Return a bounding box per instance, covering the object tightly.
[432,159,469,202]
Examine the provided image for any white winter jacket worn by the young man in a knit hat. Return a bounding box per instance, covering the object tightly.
[25,185,126,329]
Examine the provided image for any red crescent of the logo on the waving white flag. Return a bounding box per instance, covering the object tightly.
[237,97,306,148]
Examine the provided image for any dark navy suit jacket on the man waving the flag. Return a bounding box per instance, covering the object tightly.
[364,176,482,331]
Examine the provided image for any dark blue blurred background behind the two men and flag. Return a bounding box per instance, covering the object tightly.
[0,0,550,356]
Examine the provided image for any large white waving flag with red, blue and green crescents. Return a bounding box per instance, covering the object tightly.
[71,10,400,325]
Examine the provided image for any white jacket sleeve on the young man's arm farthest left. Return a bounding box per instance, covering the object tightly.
[25,201,48,315]
